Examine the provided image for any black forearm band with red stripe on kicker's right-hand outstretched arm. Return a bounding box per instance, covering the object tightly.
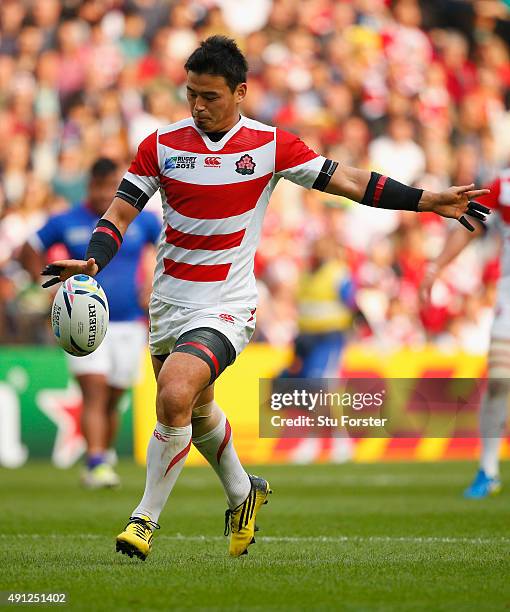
[361,172,423,212]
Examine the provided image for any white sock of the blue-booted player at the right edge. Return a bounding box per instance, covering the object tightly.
[480,393,508,478]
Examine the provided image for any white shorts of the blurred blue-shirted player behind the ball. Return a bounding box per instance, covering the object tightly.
[66,321,147,389]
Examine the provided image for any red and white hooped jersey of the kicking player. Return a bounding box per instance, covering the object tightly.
[125,117,326,306]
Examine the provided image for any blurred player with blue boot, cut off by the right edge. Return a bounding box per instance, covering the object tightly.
[422,168,510,499]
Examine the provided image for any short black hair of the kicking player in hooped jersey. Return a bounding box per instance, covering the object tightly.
[184,36,248,92]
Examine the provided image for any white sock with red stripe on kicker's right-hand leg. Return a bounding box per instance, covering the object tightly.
[193,404,251,509]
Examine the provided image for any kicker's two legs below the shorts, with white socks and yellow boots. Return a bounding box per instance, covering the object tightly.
[117,346,270,559]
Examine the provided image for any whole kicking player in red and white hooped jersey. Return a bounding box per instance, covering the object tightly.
[44,36,486,559]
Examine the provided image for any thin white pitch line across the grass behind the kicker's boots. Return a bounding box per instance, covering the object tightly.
[0,533,510,545]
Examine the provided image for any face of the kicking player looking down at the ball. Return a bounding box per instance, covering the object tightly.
[186,71,246,132]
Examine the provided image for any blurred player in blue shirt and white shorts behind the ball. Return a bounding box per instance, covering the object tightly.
[20,158,161,488]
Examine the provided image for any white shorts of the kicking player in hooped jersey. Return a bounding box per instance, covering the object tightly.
[149,296,255,356]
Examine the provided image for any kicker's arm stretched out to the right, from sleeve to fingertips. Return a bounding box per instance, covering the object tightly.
[325,164,490,232]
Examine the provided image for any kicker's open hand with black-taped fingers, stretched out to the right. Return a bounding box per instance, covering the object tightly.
[419,184,491,232]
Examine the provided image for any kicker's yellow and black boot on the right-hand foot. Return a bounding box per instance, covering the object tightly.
[225,474,272,557]
